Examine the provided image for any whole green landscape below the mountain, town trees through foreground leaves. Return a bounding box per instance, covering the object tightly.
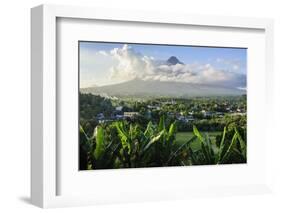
[79,94,247,170]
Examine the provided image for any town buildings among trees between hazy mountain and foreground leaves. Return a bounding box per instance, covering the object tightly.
[80,94,246,134]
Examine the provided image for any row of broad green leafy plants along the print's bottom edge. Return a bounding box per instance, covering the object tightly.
[80,117,247,169]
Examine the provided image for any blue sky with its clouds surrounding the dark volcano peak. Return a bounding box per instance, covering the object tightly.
[79,42,247,87]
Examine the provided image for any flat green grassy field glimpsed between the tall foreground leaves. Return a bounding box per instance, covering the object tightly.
[176,132,221,151]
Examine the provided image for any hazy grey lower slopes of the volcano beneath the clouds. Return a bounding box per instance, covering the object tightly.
[80,79,245,97]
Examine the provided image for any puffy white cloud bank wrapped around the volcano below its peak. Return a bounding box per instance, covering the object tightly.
[99,44,246,88]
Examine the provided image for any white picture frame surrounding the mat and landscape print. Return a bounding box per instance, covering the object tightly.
[31,5,273,208]
